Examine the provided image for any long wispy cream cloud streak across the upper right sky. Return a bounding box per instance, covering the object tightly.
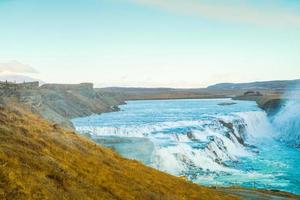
[130,0,300,27]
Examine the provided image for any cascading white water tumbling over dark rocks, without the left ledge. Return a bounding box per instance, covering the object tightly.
[152,111,271,175]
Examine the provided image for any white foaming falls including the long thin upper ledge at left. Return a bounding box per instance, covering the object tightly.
[76,111,269,175]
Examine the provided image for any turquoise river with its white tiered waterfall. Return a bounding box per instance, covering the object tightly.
[73,99,300,194]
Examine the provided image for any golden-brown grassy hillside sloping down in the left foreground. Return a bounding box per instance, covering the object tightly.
[0,106,239,200]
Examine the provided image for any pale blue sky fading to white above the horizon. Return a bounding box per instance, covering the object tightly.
[0,0,300,87]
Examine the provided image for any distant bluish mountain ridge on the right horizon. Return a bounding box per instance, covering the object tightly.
[207,79,300,90]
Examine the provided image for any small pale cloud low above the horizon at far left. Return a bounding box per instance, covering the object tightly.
[0,61,37,73]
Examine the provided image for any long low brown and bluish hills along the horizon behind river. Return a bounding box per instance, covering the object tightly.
[96,79,300,100]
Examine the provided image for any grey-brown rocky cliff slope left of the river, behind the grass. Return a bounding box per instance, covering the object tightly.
[0,83,122,130]
